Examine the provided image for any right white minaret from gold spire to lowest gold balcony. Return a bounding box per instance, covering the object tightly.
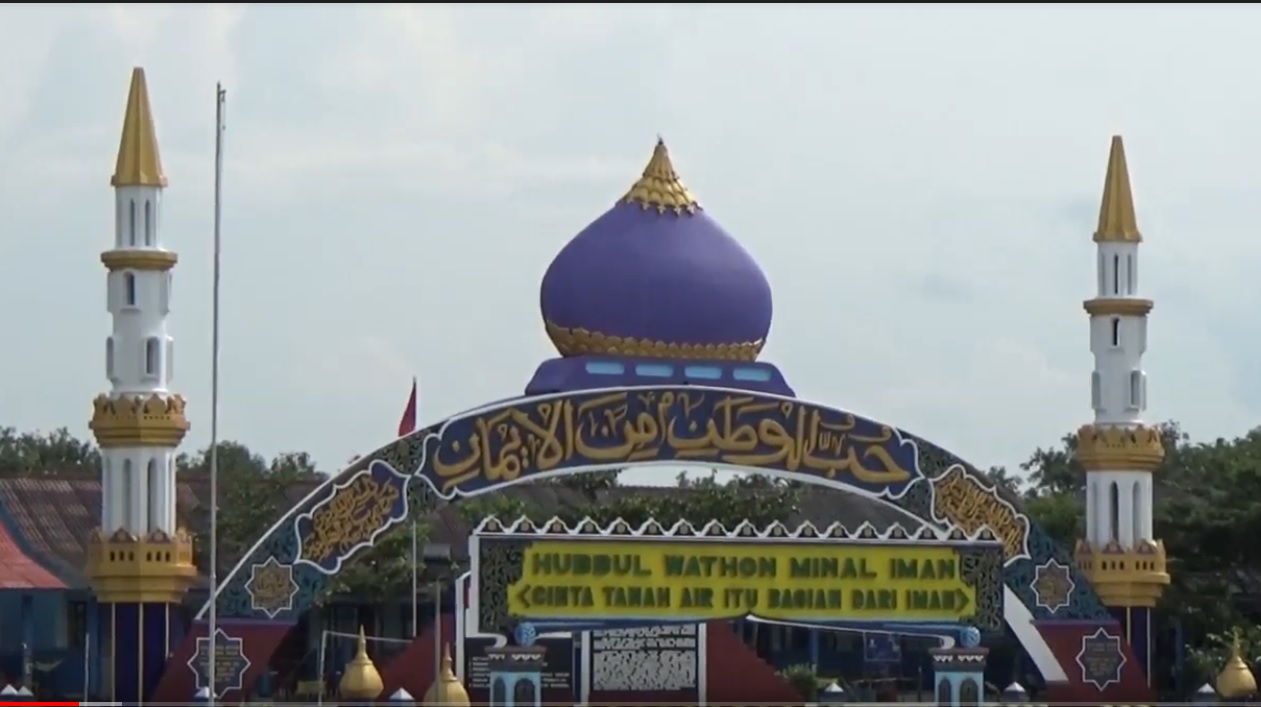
[1077,136,1169,607]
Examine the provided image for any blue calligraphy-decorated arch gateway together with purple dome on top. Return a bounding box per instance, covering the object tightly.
[154,144,1145,702]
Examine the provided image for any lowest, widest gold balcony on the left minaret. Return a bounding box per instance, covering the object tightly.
[84,528,197,604]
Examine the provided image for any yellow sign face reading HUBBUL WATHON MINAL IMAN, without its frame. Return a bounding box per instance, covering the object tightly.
[508,539,977,623]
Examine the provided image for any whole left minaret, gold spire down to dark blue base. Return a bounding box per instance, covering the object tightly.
[84,68,197,704]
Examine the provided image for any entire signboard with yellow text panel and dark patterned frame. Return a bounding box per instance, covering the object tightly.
[473,516,1002,630]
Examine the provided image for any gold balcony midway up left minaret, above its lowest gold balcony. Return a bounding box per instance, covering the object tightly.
[88,394,189,449]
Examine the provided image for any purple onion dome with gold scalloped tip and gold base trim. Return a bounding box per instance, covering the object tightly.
[541,141,772,360]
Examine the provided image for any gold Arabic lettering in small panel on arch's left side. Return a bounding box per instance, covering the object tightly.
[303,476,401,562]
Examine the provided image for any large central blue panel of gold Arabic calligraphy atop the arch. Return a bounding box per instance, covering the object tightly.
[419,386,922,498]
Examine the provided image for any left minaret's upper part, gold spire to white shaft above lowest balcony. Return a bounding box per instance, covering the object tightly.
[92,68,188,538]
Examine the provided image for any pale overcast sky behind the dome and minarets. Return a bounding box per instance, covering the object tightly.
[0,4,1261,481]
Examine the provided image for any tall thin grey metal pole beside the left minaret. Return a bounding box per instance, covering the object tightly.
[206,83,228,704]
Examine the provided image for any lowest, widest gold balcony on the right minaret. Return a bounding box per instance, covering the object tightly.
[1073,541,1169,607]
